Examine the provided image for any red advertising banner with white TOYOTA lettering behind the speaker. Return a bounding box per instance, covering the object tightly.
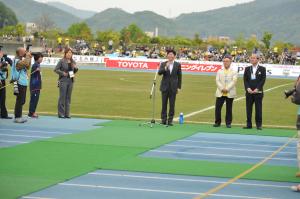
[106,59,222,73]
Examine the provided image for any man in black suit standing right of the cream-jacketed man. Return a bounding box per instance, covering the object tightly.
[244,54,266,130]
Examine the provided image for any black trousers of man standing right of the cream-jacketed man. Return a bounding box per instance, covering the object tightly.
[246,93,264,127]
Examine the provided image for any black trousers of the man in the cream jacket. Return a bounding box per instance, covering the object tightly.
[215,96,233,125]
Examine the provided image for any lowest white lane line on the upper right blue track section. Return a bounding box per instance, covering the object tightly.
[149,150,297,161]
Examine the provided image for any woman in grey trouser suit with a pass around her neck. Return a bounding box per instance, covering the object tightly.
[54,48,78,119]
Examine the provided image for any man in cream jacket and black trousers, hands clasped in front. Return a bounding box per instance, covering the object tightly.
[213,55,237,128]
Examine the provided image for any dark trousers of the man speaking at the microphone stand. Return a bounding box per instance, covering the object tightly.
[161,90,177,124]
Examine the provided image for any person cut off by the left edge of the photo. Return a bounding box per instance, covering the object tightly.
[0,46,12,119]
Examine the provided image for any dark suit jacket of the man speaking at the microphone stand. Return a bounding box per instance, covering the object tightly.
[158,61,182,92]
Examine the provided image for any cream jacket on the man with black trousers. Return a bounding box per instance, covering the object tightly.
[216,68,237,98]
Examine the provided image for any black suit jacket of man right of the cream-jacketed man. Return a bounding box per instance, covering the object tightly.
[244,65,266,92]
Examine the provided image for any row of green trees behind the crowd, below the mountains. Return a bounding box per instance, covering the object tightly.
[0,19,294,52]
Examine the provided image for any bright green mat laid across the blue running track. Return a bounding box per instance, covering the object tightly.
[0,121,300,199]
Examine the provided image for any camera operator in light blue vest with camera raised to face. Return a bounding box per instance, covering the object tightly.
[11,47,31,123]
